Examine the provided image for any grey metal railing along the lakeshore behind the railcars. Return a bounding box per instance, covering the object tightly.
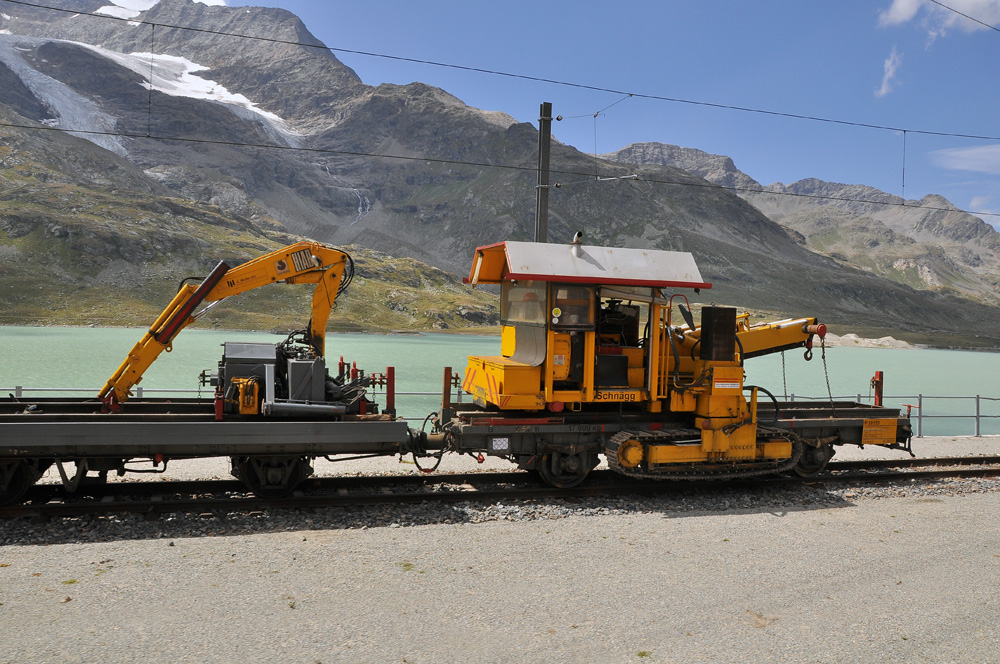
[0,385,1000,438]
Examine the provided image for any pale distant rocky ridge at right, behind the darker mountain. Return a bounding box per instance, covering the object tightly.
[603,143,1000,306]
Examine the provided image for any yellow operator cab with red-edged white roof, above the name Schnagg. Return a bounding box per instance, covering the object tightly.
[463,242,711,412]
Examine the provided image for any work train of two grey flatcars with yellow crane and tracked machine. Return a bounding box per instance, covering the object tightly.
[0,239,912,504]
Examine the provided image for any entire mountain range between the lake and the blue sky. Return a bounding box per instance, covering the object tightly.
[0,0,1000,348]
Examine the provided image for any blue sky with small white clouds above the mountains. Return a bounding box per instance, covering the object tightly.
[226,0,1000,226]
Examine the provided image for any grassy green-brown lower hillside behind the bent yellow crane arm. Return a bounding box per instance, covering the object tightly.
[0,105,498,331]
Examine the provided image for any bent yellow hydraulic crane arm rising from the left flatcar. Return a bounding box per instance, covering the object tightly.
[98,242,354,408]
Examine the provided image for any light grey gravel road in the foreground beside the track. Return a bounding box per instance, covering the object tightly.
[0,437,1000,664]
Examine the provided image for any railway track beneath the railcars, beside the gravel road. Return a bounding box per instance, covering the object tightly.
[0,456,1000,520]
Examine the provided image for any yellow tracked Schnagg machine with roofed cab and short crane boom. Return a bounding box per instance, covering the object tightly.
[463,242,825,468]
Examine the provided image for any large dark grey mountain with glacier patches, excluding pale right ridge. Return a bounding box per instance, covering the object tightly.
[0,0,1000,346]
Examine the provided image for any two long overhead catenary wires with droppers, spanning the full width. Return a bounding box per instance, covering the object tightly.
[0,0,1000,222]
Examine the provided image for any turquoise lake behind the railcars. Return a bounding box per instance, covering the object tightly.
[0,327,1000,435]
